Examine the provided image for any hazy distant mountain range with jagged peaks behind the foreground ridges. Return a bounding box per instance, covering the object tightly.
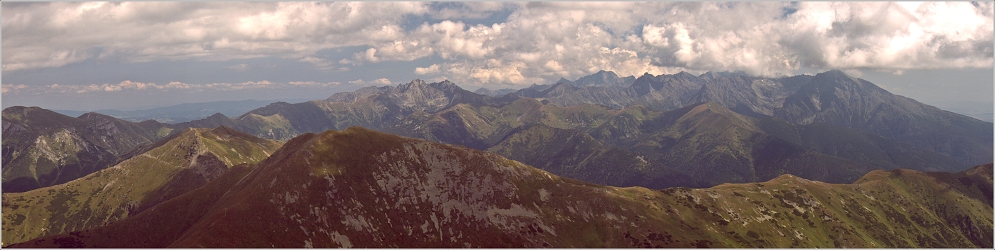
[116,71,992,188]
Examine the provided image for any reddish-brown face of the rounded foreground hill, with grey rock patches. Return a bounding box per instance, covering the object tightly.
[165,128,708,247]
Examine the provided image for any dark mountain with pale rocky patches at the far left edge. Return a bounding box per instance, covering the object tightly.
[3,106,172,192]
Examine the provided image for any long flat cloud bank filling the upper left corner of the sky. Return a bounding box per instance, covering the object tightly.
[2,2,427,71]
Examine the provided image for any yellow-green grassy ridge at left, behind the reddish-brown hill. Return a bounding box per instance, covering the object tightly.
[3,127,280,244]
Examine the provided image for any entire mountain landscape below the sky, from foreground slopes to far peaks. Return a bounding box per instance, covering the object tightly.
[2,71,993,248]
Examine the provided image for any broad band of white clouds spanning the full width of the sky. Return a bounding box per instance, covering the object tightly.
[2,2,995,86]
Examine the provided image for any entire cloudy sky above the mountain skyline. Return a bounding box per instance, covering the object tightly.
[0,1,995,116]
